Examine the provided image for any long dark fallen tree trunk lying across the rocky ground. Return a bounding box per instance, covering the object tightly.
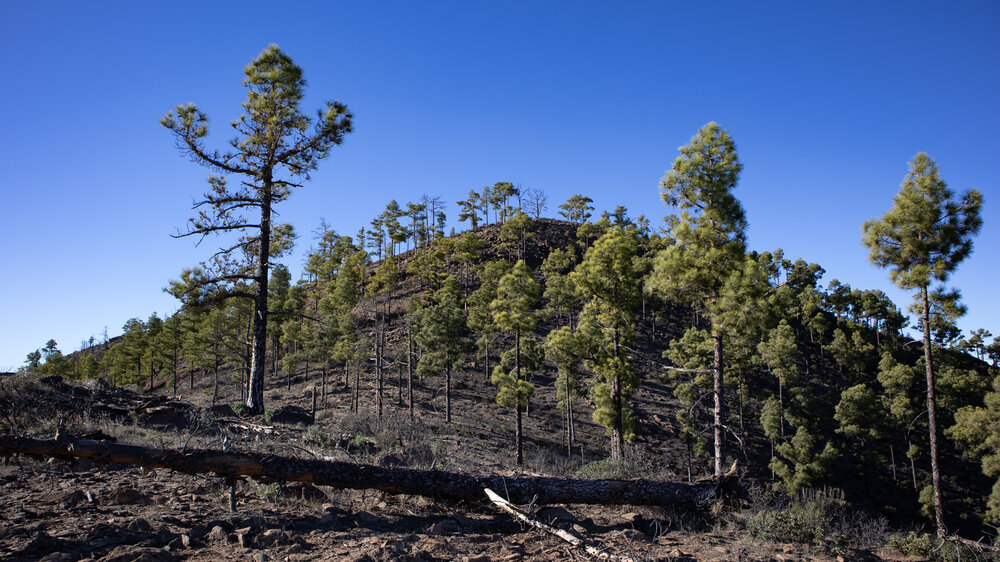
[0,436,727,508]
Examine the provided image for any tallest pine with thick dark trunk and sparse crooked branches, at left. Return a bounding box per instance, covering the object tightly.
[160,45,351,414]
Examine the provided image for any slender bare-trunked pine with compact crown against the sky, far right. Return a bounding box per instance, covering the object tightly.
[863,152,983,537]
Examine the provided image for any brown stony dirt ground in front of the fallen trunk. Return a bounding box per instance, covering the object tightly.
[0,459,892,562]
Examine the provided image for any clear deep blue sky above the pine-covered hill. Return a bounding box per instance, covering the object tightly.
[0,1,1000,369]
